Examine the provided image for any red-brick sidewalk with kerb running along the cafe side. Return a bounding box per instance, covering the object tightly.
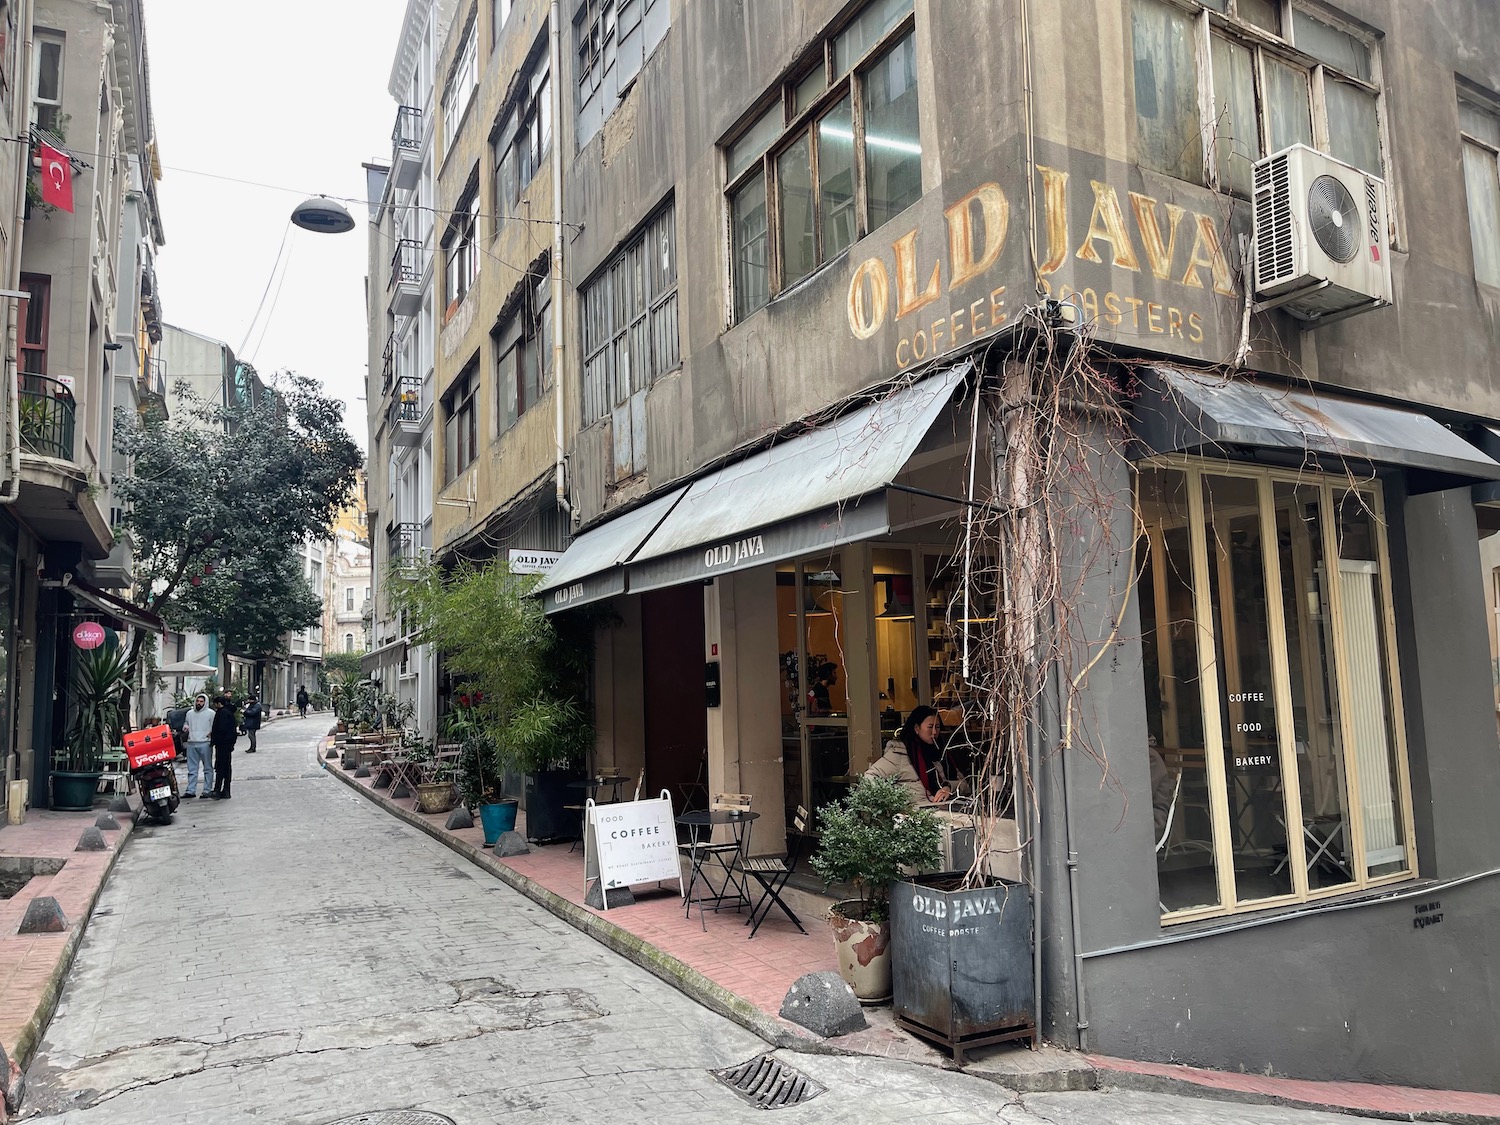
[320,741,1500,1125]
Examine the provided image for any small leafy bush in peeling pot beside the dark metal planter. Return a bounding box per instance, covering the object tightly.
[813,777,942,1004]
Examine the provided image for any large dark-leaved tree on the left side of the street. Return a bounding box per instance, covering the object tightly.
[114,372,363,680]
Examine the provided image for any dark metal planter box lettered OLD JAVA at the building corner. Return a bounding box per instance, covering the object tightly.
[891,873,1037,1065]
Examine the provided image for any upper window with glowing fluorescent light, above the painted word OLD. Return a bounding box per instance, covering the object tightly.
[725,0,923,321]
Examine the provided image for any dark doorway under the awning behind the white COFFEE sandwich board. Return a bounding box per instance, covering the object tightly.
[641,584,708,810]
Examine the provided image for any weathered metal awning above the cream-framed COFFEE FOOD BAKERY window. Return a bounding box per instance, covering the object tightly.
[1134,366,1500,492]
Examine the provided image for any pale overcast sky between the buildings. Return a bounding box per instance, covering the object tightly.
[144,0,407,459]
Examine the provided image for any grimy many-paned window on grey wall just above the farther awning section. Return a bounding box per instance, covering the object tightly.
[579,204,681,426]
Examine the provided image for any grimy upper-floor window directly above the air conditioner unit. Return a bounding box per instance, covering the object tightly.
[1131,0,1385,195]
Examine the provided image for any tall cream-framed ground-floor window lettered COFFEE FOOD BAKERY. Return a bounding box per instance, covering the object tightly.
[1136,462,1416,921]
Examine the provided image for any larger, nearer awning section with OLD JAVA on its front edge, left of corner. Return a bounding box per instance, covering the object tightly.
[629,363,972,593]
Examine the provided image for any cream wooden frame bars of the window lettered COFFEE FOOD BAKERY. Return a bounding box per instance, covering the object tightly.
[1134,456,1419,926]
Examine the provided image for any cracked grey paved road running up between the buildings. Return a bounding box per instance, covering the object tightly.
[17,717,1410,1125]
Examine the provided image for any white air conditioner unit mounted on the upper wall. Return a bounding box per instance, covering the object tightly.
[1254,144,1391,321]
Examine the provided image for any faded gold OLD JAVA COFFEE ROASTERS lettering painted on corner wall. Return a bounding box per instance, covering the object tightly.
[848,165,1236,368]
